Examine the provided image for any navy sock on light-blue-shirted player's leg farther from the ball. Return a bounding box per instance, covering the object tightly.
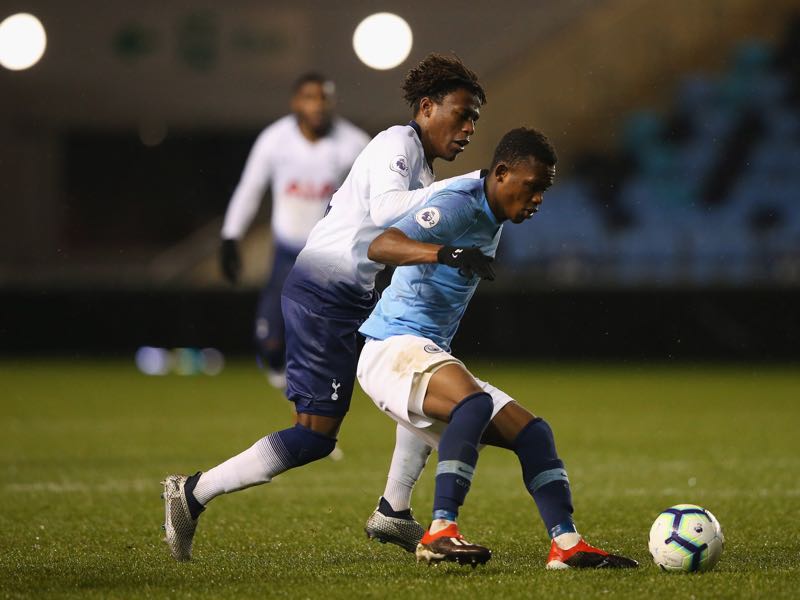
[433,392,493,521]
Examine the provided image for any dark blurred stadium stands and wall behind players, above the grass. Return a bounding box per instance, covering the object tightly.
[0,0,800,361]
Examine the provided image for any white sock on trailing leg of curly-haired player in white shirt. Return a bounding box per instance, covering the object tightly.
[194,433,293,506]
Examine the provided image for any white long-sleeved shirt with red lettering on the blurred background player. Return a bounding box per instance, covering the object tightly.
[222,115,369,250]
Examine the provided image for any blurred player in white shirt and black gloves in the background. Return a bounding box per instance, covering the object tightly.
[220,73,369,389]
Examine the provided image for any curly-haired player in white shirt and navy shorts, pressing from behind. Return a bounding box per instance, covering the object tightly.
[163,54,486,560]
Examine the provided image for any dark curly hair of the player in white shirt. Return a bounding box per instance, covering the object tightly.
[403,53,486,114]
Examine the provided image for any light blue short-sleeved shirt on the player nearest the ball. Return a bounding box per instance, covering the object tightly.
[359,179,503,352]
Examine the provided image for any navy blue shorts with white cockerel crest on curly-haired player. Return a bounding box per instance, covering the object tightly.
[281,296,368,417]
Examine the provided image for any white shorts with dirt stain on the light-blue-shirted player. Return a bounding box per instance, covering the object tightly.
[356,335,514,448]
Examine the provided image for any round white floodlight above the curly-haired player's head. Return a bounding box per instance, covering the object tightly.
[353,13,414,70]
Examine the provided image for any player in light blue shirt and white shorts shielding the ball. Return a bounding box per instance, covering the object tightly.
[357,128,637,569]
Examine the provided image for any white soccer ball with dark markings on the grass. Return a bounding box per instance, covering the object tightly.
[649,504,725,573]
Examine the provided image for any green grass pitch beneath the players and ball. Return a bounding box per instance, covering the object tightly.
[0,361,800,599]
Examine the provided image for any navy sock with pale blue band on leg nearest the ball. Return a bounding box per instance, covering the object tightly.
[514,418,576,538]
